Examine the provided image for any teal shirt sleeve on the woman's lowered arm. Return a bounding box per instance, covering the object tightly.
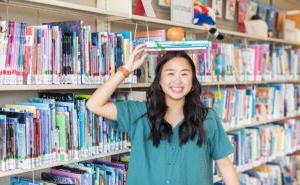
[206,110,233,160]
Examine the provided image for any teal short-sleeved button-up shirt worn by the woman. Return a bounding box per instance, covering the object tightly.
[116,101,233,185]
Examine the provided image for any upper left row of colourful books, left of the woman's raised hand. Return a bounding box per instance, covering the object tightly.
[0,20,136,84]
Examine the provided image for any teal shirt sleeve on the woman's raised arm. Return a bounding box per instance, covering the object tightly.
[115,100,147,137]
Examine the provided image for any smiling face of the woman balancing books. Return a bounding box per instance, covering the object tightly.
[159,57,193,101]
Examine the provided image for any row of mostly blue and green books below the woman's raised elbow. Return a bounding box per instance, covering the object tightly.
[0,92,129,171]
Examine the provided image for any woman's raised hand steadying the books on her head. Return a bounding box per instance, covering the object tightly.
[124,44,148,73]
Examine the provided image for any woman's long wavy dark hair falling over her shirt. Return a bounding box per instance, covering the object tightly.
[147,51,208,147]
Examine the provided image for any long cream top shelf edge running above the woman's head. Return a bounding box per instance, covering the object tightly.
[1,0,300,46]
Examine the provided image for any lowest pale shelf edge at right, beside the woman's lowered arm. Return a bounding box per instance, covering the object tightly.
[213,145,300,182]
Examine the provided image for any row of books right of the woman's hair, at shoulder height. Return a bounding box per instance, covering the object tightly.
[202,84,300,129]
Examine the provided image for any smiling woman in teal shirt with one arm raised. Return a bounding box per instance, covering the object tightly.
[87,45,239,185]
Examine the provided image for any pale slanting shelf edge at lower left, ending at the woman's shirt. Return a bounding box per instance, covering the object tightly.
[0,149,130,178]
